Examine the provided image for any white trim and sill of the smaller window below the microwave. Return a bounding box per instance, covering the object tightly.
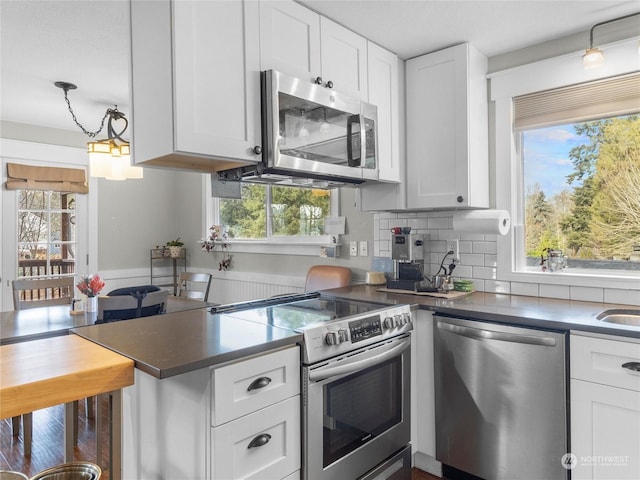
[202,174,340,257]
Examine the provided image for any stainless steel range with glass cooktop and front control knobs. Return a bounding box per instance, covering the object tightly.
[216,294,413,480]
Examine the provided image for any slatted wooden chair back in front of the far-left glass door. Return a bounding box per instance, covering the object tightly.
[11,277,75,310]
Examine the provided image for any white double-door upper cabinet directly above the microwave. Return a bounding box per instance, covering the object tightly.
[260,0,368,101]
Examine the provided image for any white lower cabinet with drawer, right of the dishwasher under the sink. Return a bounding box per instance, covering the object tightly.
[571,334,640,480]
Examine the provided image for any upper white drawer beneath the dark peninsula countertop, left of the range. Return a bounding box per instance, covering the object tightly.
[211,346,300,426]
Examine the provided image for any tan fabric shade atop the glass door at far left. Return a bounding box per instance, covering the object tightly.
[6,163,89,193]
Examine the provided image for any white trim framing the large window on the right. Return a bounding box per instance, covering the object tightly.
[488,38,640,290]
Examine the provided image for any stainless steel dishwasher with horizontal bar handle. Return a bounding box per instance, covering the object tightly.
[434,315,569,480]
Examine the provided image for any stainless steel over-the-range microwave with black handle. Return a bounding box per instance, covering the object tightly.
[218,70,378,188]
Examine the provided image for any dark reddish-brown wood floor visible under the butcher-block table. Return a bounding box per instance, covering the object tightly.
[0,402,440,480]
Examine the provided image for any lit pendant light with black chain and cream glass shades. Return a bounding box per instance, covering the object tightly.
[54,82,142,180]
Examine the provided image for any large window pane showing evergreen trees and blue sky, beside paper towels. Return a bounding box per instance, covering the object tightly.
[518,115,640,270]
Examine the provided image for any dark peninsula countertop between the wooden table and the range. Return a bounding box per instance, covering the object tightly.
[71,308,302,378]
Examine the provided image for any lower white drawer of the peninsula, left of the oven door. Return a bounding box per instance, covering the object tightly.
[212,395,300,480]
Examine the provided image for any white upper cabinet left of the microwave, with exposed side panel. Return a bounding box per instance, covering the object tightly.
[131,0,262,171]
